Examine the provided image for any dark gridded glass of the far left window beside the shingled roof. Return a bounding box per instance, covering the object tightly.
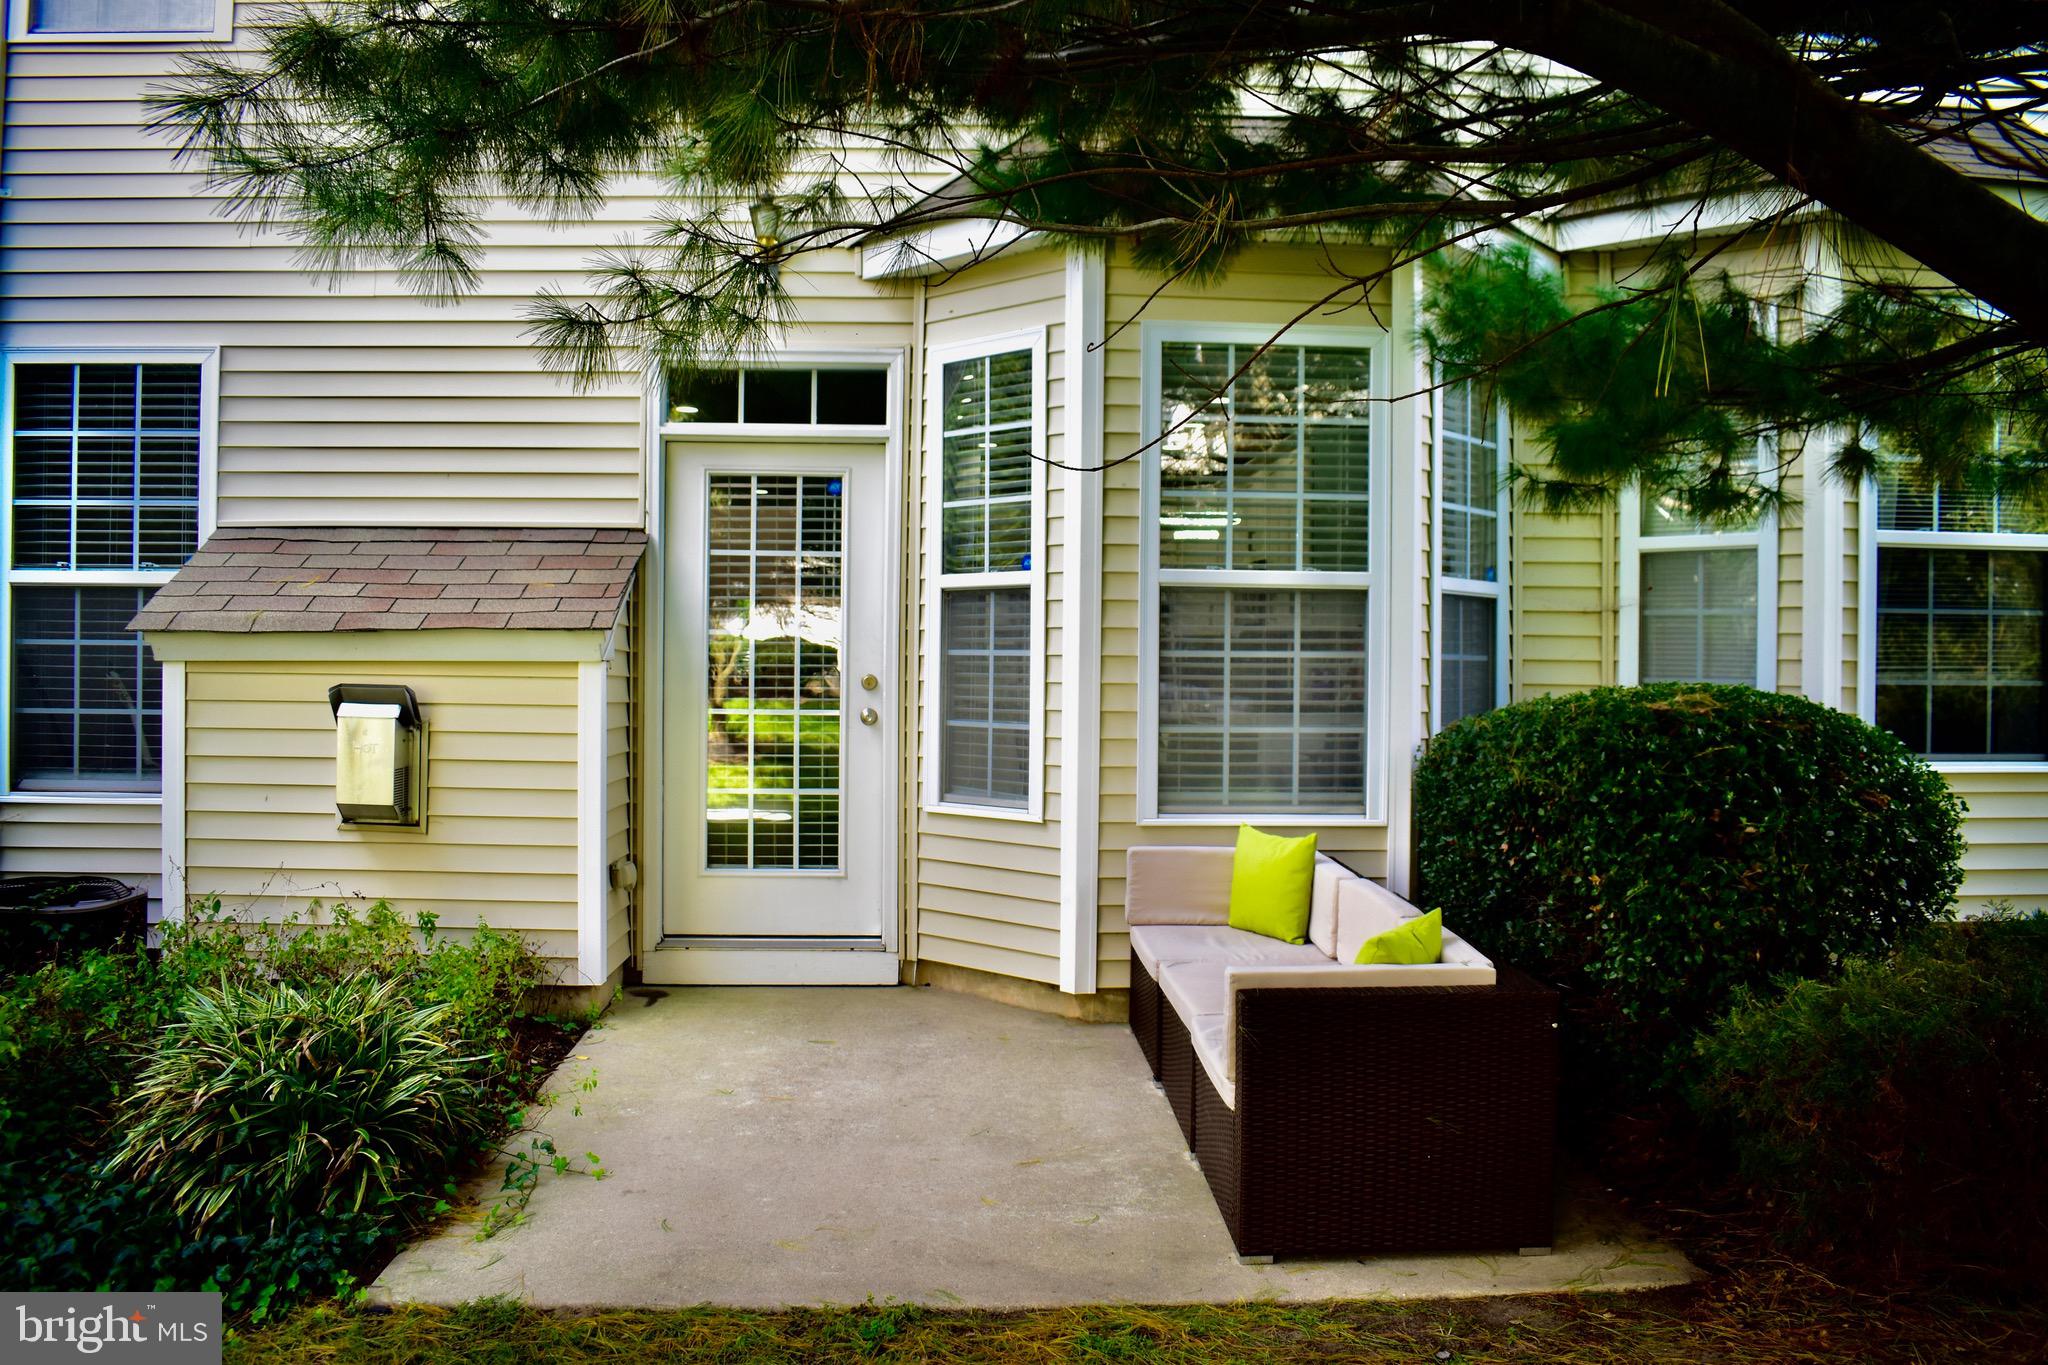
[0,360,205,792]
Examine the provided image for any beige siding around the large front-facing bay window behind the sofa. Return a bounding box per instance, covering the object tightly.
[1098,244,1407,988]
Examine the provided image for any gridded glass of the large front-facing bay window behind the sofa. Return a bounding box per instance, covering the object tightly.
[1149,340,1374,814]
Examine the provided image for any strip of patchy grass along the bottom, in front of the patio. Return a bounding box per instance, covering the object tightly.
[227,1263,2048,1365]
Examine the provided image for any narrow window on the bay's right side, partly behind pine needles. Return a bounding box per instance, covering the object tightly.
[1434,379,1507,726]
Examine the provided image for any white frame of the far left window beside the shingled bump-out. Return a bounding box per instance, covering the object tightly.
[0,346,221,806]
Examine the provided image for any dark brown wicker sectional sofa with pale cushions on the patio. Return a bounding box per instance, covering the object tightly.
[1124,847,1556,1261]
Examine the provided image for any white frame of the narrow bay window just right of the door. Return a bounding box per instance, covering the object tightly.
[920,327,1051,825]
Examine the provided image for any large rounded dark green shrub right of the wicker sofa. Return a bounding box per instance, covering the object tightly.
[1415,684,1962,1101]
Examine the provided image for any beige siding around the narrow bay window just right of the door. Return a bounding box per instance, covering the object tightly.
[905,250,1067,982]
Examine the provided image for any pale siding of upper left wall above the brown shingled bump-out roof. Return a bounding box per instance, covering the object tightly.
[0,30,649,526]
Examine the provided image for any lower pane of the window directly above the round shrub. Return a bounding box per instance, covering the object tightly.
[1640,548,1757,684]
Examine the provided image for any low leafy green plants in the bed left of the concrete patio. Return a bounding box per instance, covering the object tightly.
[0,902,561,1316]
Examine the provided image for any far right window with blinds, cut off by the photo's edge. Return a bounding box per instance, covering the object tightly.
[1870,465,2048,759]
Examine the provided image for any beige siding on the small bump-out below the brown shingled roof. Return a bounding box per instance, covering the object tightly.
[184,654,575,972]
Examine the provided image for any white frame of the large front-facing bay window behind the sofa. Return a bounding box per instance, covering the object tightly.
[1137,321,1393,829]
